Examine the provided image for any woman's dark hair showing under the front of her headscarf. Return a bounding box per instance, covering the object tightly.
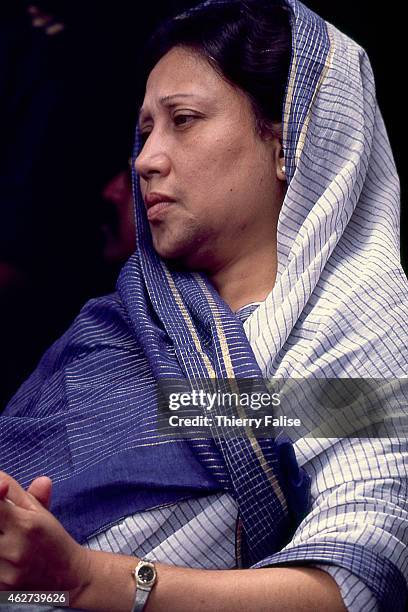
[143,0,291,133]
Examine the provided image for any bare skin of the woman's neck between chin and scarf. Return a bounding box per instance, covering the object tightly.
[208,244,277,311]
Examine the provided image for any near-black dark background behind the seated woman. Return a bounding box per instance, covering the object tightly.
[0,0,408,410]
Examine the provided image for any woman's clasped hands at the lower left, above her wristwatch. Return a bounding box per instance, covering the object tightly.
[0,472,90,604]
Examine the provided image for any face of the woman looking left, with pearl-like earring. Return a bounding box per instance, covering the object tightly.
[136,47,284,272]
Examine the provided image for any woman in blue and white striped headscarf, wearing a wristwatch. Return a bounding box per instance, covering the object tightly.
[0,0,407,611]
